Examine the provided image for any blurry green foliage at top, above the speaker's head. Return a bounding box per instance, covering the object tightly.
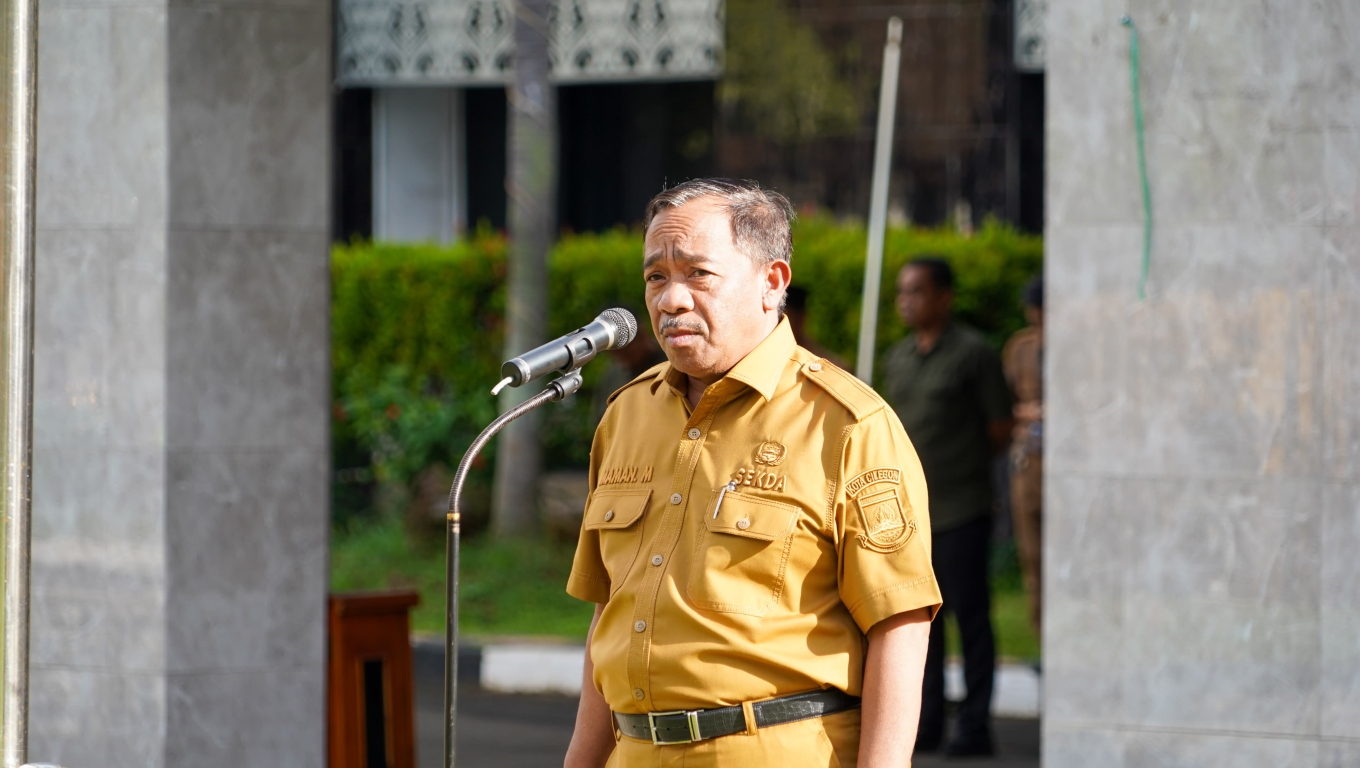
[718,0,860,145]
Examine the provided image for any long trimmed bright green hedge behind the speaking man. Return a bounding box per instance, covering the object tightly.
[332,216,1043,521]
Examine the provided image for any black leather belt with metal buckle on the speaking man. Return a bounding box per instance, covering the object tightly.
[613,688,860,744]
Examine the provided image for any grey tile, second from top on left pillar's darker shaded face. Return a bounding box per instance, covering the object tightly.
[166,231,330,451]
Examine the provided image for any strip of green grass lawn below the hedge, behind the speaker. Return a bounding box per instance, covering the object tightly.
[330,508,1039,659]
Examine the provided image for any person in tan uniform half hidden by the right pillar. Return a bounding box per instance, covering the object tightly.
[1001,277,1043,631]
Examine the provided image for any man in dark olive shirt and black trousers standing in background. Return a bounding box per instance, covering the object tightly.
[884,258,1012,756]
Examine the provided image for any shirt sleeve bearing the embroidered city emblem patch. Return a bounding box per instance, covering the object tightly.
[835,408,941,632]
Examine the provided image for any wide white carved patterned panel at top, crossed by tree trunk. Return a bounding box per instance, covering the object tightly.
[336,0,724,86]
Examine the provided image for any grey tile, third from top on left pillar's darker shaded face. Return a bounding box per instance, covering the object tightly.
[166,451,329,674]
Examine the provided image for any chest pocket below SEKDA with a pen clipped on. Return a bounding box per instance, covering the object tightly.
[688,492,798,616]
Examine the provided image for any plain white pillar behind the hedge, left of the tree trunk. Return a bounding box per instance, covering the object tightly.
[373,88,468,243]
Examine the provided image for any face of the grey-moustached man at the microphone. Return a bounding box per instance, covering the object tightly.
[642,197,790,383]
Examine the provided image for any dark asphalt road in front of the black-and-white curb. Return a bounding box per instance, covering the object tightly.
[415,647,1039,768]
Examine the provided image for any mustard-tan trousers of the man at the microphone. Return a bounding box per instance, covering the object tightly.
[605,710,860,768]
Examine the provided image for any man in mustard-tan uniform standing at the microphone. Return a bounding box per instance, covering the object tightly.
[566,179,940,768]
